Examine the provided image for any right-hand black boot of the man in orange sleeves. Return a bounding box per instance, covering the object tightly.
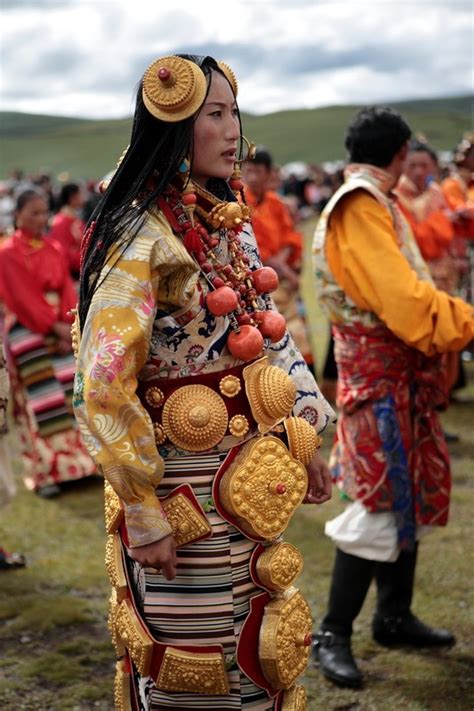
[372,544,456,647]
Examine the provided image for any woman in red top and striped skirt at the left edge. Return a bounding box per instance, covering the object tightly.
[0,190,95,496]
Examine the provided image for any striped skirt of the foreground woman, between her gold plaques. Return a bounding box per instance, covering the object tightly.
[127,454,274,711]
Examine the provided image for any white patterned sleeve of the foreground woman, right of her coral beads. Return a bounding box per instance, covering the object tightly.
[242,225,336,433]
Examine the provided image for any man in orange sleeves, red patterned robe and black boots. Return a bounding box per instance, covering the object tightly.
[313,108,474,687]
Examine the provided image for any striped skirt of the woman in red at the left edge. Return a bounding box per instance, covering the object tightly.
[7,323,96,490]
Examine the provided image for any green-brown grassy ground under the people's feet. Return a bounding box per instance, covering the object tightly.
[0,224,474,711]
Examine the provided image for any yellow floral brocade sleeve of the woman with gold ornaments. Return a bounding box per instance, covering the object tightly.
[74,233,171,547]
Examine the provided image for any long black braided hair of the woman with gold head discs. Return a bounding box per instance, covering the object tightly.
[79,54,242,327]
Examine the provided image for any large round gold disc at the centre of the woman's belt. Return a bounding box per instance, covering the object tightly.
[162,385,229,452]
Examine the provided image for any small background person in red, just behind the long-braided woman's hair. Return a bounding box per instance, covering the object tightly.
[48,183,85,281]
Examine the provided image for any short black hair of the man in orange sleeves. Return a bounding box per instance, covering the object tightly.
[344,106,411,168]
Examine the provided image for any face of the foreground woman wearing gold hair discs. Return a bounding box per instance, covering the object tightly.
[191,72,240,186]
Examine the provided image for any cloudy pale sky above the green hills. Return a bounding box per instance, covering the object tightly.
[0,0,474,118]
